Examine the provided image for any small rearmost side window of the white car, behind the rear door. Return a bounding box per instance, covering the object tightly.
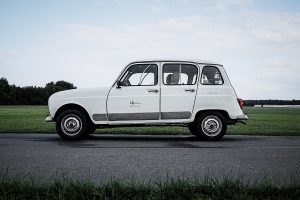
[201,66,224,85]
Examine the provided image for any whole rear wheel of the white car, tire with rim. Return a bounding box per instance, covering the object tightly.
[189,111,227,141]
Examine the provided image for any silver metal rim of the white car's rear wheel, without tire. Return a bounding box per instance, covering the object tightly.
[201,115,222,137]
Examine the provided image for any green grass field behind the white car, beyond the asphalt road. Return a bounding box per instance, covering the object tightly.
[0,106,300,135]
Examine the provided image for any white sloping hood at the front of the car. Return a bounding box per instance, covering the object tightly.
[49,87,109,100]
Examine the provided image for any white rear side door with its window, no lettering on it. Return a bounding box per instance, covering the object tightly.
[161,63,199,120]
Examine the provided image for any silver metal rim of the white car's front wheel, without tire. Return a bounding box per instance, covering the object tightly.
[60,114,82,136]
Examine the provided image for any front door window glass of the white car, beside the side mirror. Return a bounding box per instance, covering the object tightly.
[120,64,158,86]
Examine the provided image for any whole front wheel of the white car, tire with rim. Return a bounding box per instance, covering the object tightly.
[56,110,89,140]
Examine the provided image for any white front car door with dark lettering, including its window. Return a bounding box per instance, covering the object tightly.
[107,62,160,124]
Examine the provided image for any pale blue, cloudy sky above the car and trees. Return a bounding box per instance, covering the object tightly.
[0,0,300,99]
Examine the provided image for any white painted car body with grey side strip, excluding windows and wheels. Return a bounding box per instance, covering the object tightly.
[47,60,247,125]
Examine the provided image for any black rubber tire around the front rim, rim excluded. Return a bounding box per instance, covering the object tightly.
[56,110,89,140]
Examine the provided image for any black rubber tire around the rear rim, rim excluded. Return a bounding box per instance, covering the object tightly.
[193,111,227,141]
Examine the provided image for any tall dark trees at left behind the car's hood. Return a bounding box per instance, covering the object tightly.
[0,77,76,105]
